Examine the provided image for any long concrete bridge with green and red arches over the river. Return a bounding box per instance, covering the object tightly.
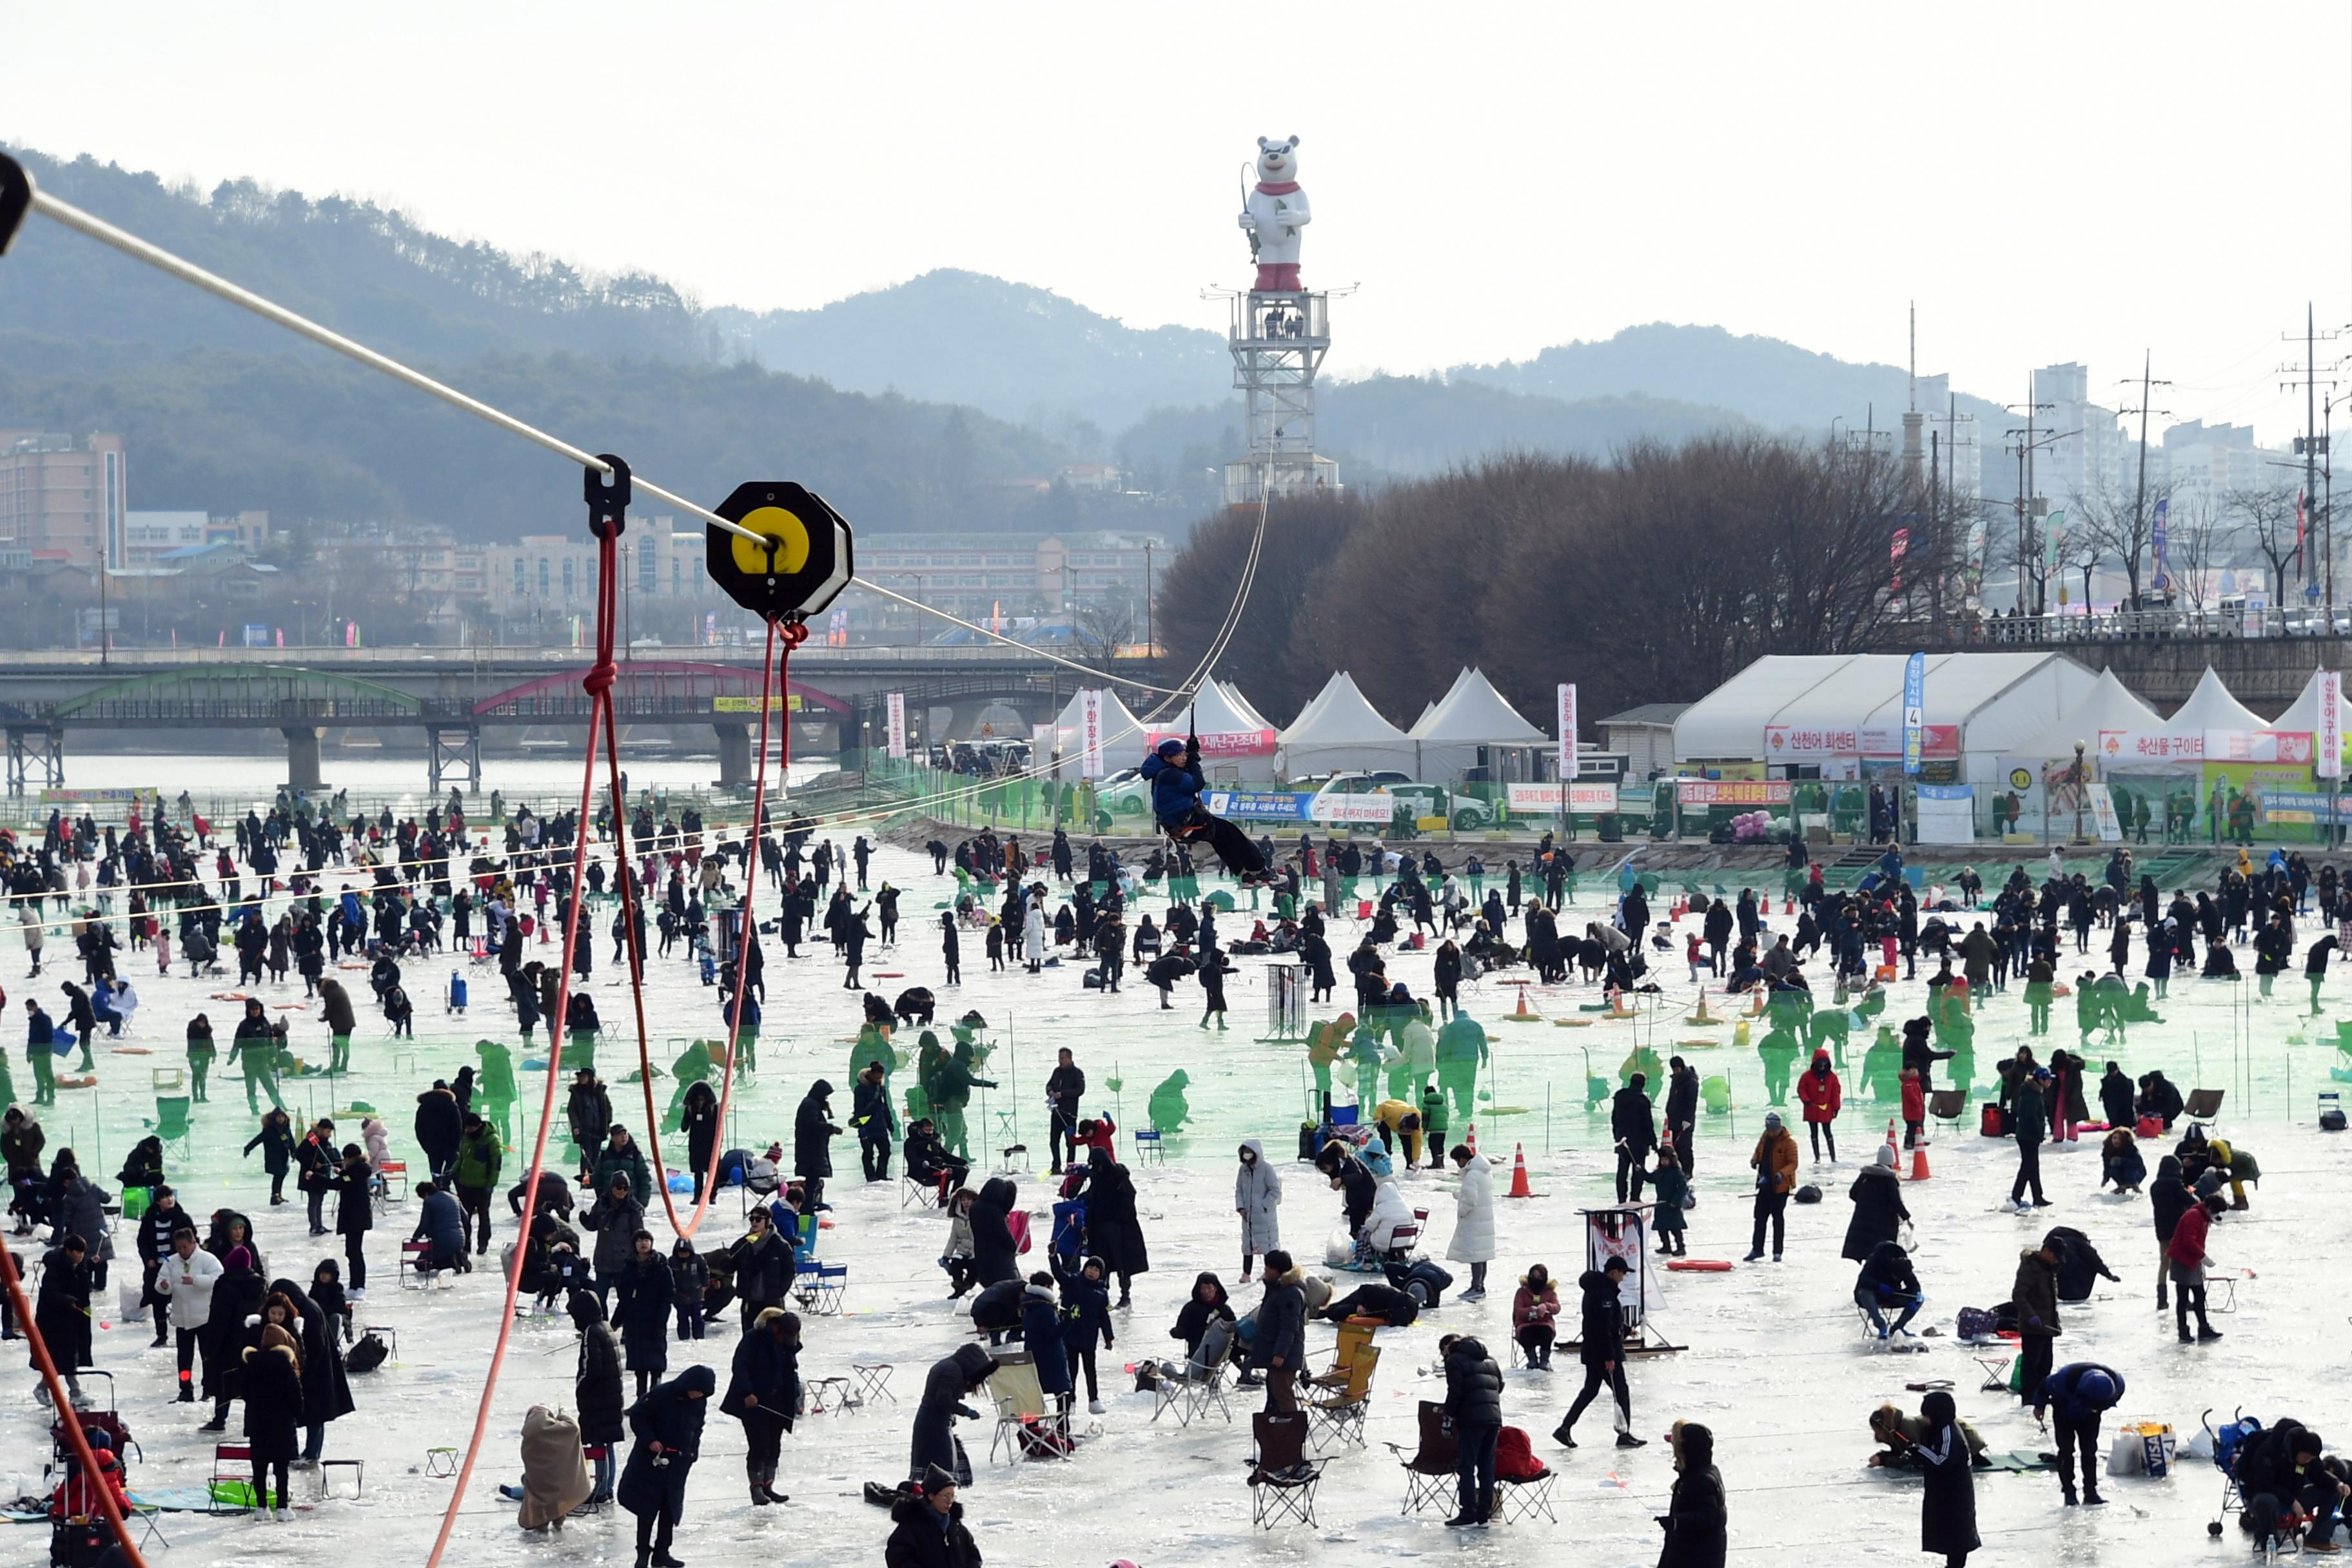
[0,647,1153,794]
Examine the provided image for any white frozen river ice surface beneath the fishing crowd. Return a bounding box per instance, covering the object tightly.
[0,830,2352,1565]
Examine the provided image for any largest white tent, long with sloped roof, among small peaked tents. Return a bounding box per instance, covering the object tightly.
[1674,654,2098,783]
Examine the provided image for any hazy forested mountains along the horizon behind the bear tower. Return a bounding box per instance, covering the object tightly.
[0,150,1997,538]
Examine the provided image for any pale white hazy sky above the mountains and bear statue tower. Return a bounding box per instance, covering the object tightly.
[0,0,2352,442]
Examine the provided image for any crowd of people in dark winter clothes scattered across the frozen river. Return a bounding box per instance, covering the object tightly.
[0,790,2342,1565]
